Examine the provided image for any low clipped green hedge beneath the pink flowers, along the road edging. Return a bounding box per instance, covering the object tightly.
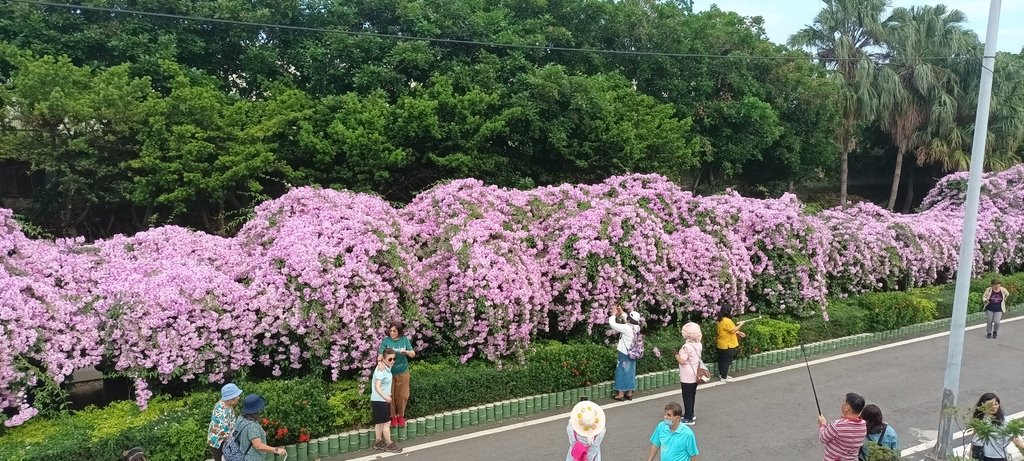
[0,274,1024,461]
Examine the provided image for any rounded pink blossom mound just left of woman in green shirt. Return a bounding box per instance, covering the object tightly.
[236,187,419,379]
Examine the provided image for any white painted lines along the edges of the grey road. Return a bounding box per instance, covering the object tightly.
[349,316,1024,461]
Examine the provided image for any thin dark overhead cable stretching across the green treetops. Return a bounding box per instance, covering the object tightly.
[8,0,978,61]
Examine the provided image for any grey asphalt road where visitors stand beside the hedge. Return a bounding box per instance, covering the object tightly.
[332,318,1024,461]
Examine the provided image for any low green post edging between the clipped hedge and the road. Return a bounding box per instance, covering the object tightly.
[237,304,1024,461]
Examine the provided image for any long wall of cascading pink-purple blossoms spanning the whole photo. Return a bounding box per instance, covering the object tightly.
[0,166,1024,426]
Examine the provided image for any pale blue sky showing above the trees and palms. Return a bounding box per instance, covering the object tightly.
[693,0,1024,53]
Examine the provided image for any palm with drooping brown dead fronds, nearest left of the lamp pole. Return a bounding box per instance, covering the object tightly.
[876,5,978,210]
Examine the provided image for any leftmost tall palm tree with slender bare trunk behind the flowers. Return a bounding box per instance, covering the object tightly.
[788,0,889,208]
